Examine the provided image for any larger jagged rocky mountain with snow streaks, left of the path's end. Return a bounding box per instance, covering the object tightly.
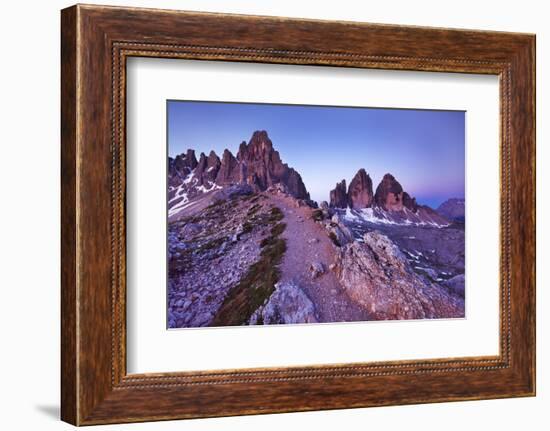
[168,130,310,218]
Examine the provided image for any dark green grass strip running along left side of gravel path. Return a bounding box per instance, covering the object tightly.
[210,207,286,326]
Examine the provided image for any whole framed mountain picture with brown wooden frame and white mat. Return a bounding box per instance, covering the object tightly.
[61,5,535,425]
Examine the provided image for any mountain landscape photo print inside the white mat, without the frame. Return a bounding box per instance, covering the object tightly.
[167,100,466,329]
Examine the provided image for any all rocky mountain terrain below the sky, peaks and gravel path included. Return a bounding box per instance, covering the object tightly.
[167,131,465,328]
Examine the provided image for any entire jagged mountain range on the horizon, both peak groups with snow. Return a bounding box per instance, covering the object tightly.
[168,130,464,226]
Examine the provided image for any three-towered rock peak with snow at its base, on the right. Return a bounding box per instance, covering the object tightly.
[330,169,449,227]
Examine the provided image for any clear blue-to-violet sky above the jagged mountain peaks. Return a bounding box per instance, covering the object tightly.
[167,100,465,208]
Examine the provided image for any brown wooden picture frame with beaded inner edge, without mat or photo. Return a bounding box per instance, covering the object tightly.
[61,5,535,425]
